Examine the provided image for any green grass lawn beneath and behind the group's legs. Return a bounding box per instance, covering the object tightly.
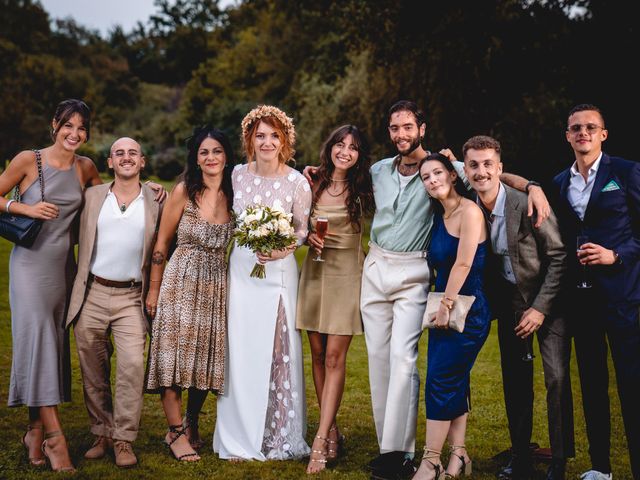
[0,202,631,480]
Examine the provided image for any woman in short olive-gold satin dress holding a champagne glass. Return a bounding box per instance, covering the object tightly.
[296,125,373,473]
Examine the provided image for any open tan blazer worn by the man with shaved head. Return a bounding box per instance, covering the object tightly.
[65,182,162,327]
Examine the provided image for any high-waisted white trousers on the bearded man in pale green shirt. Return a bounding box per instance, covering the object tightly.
[360,243,429,453]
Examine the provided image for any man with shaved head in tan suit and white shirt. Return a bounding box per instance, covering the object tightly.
[67,137,161,467]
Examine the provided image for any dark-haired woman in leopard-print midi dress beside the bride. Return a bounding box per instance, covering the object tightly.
[145,127,233,461]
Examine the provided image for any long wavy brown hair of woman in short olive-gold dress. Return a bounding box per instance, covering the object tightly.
[313,125,374,232]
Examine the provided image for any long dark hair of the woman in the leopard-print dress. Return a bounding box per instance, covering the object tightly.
[182,125,235,210]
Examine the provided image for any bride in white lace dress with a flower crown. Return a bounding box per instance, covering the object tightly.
[213,105,311,460]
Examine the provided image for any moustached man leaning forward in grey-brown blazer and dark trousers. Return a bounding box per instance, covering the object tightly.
[462,135,575,480]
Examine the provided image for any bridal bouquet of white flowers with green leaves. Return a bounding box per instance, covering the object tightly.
[233,200,297,278]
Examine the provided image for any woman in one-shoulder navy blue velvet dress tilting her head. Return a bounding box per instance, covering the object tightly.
[413,153,490,480]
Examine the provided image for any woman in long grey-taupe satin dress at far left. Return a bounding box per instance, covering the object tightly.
[0,100,102,471]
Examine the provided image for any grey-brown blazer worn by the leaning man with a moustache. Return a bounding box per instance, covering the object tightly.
[496,184,567,316]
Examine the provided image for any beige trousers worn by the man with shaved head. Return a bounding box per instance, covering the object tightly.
[74,282,147,442]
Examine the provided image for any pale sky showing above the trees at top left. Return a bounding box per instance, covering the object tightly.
[40,0,233,36]
